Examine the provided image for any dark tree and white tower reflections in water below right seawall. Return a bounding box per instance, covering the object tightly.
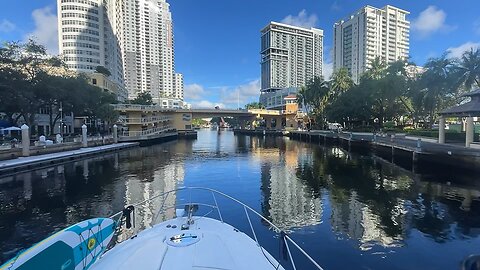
[288,142,480,250]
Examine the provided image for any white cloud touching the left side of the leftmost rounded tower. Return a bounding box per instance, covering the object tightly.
[26,6,58,54]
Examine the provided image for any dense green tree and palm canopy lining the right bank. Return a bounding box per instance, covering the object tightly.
[297,49,480,131]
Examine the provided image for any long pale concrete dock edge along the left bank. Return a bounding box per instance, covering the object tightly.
[0,142,139,175]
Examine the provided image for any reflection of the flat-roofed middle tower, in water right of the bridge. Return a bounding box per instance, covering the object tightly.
[249,137,323,231]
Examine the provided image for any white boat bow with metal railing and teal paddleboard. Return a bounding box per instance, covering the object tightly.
[0,187,322,270]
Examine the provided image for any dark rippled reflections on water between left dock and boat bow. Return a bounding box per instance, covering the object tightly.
[0,142,192,262]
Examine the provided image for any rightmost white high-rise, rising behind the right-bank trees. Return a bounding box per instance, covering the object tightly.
[333,5,410,83]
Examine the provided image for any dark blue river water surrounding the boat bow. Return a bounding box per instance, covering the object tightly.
[0,130,480,269]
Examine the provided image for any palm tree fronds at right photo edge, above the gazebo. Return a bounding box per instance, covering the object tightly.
[456,48,480,90]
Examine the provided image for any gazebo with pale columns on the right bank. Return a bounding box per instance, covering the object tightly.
[438,88,480,147]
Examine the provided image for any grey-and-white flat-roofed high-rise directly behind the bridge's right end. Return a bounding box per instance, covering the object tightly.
[260,22,323,93]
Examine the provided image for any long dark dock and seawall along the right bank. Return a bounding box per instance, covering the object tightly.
[288,131,480,171]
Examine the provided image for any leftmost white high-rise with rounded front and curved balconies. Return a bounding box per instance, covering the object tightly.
[57,0,123,84]
